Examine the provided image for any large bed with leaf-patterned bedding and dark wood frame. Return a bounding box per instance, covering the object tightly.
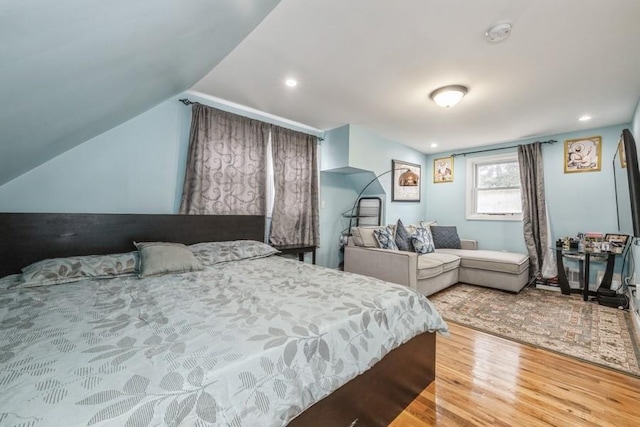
[0,214,447,426]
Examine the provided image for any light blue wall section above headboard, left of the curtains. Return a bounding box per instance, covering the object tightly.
[0,101,191,213]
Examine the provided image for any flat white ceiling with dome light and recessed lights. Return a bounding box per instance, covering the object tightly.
[192,0,640,153]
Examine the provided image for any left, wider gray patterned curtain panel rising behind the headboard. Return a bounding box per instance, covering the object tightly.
[180,103,270,215]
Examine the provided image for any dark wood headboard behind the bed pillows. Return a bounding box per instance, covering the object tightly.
[0,213,265,277]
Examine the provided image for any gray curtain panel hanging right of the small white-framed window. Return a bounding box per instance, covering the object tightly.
[518,142,556,277]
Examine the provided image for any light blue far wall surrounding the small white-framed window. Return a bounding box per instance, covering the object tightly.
[424,125,628,252]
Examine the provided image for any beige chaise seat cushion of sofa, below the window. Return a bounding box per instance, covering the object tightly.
[436,249,529,274]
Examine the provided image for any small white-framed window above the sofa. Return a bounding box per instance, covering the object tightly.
[467,153,522,221]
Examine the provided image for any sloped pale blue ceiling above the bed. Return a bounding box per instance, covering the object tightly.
[0,0,279,185]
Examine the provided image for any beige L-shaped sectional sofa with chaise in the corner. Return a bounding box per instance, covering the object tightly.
[344,226,529,296]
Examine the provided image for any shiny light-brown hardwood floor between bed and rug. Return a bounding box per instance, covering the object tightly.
[391,323,640,427]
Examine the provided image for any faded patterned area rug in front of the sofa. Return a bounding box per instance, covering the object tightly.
[429,284,640,377]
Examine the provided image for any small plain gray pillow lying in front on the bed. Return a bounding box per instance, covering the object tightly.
[133,242,202,277]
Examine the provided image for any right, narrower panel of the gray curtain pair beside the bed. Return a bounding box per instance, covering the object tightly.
[269,126,319,246]
